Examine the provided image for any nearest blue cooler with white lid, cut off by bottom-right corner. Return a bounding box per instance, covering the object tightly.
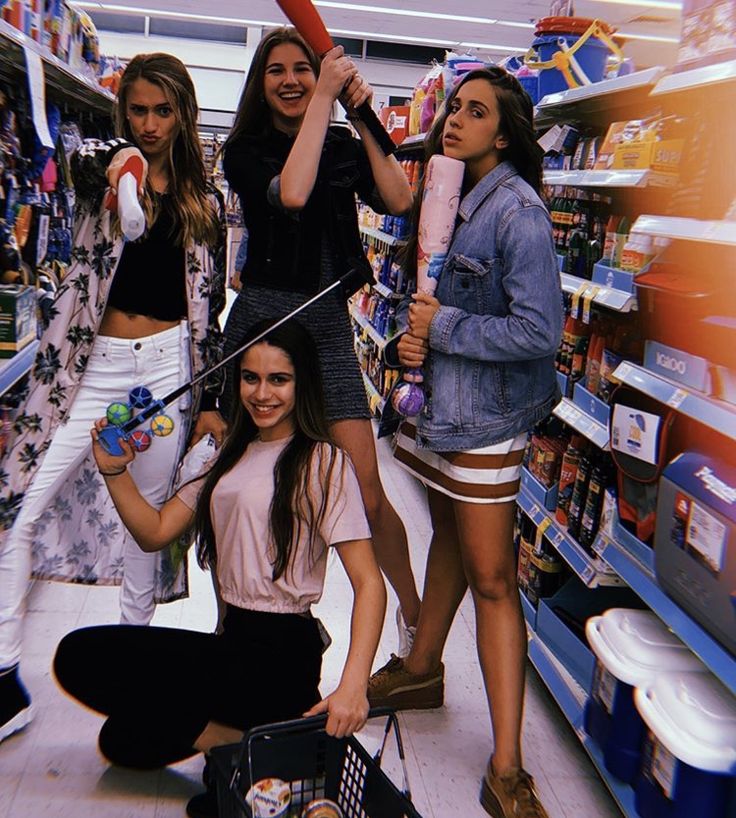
[634,673,736,818]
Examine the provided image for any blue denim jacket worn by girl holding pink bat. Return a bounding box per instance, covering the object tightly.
[382,162,563,451]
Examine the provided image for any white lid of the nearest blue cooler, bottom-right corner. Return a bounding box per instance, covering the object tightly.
[634,673,736,774]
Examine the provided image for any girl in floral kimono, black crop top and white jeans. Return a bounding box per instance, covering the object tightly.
[0,49,225,740]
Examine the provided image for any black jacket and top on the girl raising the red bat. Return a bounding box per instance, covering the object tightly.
[223,126,386,295]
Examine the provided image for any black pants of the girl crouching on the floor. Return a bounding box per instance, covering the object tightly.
[54,606,322,769]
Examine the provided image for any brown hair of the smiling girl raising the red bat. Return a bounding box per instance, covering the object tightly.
[223,26,320,150]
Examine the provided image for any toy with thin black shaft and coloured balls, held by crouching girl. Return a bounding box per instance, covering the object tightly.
[98,260,372,456]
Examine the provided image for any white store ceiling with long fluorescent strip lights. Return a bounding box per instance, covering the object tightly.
[77,0,680,67]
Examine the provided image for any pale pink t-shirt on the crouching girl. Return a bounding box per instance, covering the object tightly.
[177,438,371,613]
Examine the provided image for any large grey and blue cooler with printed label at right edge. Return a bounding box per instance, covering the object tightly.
[654,452,736,653]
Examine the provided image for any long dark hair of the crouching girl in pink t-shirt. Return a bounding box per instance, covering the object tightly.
[194,319,347,581]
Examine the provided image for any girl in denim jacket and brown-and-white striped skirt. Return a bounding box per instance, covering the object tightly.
[369,68,562,818]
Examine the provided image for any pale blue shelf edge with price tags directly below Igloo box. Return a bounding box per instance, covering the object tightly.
[613,361,736,440]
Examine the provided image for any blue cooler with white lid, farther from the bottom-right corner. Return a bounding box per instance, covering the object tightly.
[585,608,705,783]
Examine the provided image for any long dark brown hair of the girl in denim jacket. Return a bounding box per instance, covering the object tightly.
[401,66,542,275]
